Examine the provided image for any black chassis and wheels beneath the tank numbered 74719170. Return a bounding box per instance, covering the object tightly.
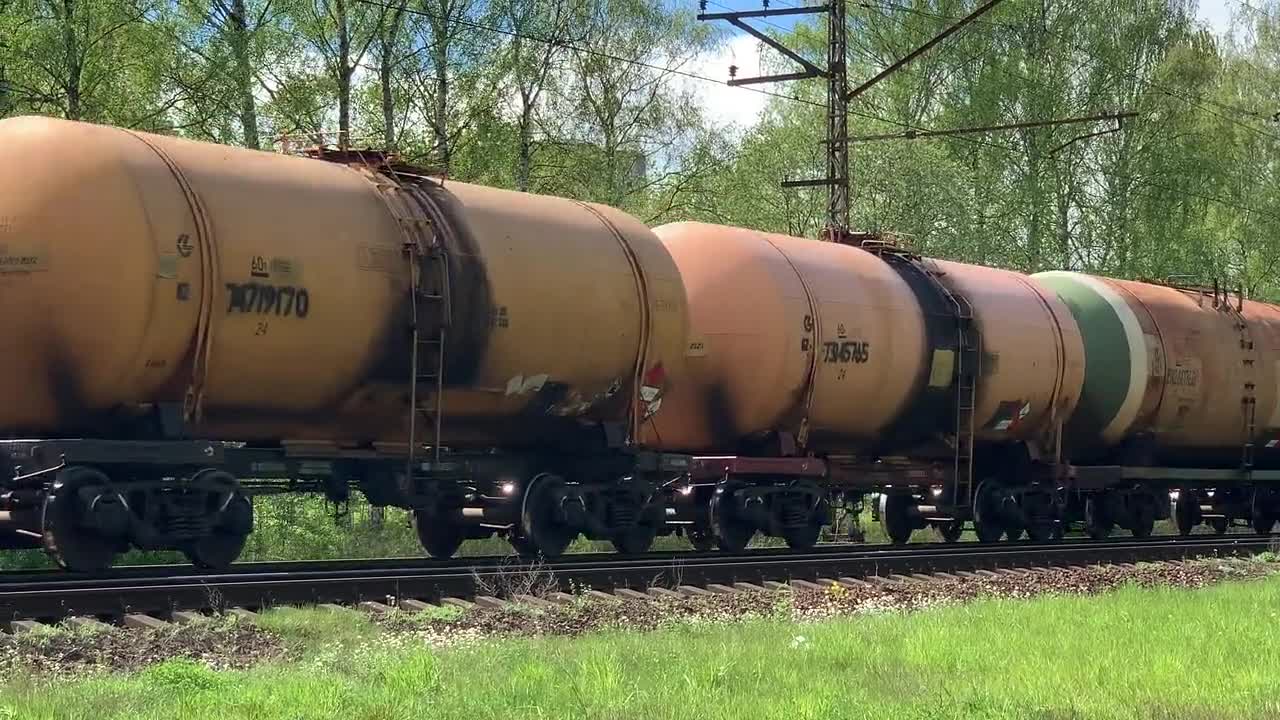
[0,430,689,571]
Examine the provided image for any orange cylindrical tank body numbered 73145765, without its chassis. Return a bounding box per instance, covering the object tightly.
[653,223,1084,452]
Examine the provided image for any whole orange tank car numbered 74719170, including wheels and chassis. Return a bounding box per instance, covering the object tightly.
[0,118,686,569]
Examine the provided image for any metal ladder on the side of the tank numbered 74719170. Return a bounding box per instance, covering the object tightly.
[376,170,452,478]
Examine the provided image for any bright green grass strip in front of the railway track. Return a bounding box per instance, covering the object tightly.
[0,568,1280,720]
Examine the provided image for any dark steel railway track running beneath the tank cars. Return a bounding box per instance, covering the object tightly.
[0,536,1275,624]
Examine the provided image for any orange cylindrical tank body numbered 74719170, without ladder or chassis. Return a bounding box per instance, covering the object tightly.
[0,118,685,445]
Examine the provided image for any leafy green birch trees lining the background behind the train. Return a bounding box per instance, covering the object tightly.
[0,0,1280,288]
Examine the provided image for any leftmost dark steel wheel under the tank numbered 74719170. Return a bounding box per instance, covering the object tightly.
[41,466,118,573]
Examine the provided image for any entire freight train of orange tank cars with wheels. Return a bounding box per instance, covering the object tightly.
[0,118,1280,571]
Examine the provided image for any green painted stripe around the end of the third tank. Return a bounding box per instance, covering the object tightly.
[1032,274,1132,438]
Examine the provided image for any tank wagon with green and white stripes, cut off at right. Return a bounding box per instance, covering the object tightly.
[1032,272,1280,532]
